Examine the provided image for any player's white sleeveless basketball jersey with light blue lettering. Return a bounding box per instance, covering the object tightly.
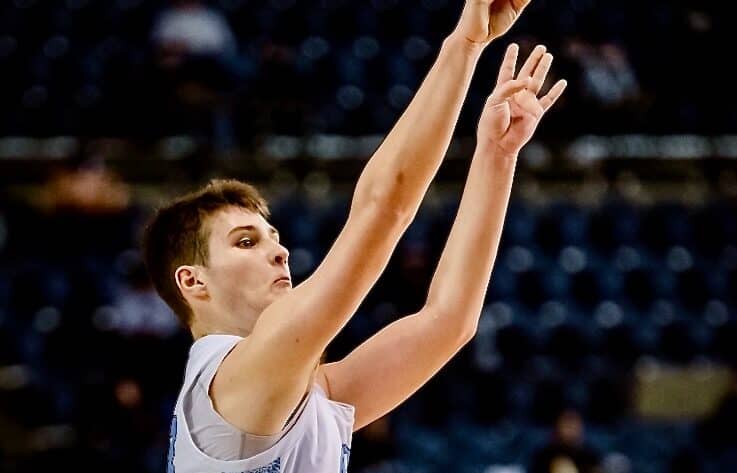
[167,335,354,473]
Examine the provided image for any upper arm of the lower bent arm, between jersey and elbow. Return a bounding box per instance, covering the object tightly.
[318,309,468,430]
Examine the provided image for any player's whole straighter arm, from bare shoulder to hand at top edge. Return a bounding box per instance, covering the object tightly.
[211,0,529,435]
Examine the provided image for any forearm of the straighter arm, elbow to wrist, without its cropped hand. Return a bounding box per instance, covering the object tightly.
[352,35,483,215]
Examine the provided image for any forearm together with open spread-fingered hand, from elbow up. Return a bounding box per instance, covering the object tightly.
[427,45,566,320]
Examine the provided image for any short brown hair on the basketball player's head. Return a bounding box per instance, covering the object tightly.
[142,179,270,327]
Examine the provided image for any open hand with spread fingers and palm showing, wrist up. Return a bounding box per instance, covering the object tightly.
[477,44,567,156]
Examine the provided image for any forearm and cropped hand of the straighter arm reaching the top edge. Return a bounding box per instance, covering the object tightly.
[352,0,530,217]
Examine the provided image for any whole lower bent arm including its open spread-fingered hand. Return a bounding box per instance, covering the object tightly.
[317,45,565,430]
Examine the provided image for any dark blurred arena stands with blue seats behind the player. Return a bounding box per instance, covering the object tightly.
[0,0,737,473]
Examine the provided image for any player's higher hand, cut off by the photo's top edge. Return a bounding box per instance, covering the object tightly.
[454,0,530,46]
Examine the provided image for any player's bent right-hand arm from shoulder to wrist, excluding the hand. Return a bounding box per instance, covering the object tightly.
[318,144,514,430]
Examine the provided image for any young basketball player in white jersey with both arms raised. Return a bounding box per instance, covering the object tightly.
[144,0,565,473]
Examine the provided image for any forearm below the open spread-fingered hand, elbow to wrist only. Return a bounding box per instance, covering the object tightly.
[426,150,516,334]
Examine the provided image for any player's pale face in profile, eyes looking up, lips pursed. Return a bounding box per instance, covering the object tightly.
[206,207,292,315]
